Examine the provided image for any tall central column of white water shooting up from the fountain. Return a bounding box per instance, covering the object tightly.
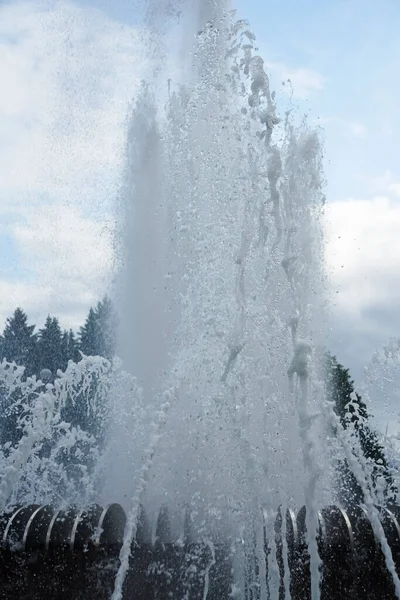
[114,1,329,600]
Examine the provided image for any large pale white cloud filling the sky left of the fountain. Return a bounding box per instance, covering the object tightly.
[0,0,145,328]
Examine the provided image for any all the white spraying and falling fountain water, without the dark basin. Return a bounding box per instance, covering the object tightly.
[0,0,400,600]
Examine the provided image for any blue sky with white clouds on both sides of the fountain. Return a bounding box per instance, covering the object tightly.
[0,0,400,428]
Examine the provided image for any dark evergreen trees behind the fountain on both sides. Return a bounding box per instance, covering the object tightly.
[0,297,395,504]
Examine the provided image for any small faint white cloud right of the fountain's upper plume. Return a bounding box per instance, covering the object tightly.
[265,62,325,98]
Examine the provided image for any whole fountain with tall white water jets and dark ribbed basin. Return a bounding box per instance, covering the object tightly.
[0,0,400,600]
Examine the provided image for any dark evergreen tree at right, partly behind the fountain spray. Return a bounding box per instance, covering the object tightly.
[325,353,393,504]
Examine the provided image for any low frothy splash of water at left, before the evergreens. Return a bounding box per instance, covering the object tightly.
[0,357,146,512]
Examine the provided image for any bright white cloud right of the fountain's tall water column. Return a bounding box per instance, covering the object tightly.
[326,191,400,329]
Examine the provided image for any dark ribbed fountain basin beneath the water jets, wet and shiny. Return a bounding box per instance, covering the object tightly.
[0,504,400,600]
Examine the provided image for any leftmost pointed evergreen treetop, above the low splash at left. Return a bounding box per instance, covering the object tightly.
[1,308,37,375]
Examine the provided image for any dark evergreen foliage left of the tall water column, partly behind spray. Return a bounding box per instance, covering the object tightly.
[0,297,117,445]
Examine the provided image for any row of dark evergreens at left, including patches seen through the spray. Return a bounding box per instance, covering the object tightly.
[0,297,117,486]
